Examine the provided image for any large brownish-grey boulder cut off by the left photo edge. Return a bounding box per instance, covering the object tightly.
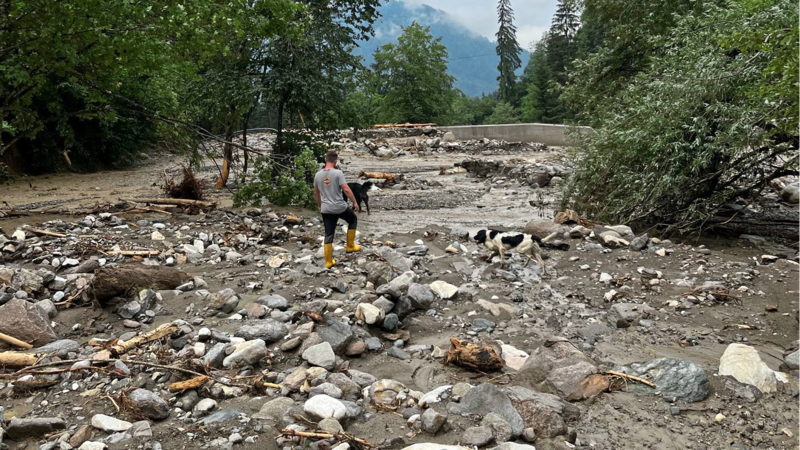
[0,298,58,347]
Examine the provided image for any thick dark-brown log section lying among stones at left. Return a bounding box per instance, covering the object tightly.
[92,265,189,301]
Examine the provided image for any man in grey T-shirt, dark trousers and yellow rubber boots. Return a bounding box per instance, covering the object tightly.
[314,151,361,269]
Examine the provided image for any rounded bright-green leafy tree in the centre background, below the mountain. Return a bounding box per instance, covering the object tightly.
[371,22,456,122]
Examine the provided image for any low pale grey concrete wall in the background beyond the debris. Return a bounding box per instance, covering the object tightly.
[441,123,592,147]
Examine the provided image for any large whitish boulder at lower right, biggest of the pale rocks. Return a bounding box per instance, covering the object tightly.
[719,344,783,393]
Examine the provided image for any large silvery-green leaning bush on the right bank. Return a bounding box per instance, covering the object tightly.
[564,0,800,228]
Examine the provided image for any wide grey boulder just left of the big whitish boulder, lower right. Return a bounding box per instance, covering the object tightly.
[620,358,709,403]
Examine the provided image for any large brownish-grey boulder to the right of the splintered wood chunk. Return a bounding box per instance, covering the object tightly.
[515,338,597,401]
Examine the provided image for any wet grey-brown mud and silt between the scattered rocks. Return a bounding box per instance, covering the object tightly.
[0,134,800,449]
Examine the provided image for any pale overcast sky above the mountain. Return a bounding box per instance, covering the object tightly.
[406,0,557,49]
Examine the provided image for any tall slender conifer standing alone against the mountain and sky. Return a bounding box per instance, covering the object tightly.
[496,0,522,103]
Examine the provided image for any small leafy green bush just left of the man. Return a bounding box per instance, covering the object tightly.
[234,148,319,209]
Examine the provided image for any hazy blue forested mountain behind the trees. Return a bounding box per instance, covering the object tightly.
[354,0,530,97]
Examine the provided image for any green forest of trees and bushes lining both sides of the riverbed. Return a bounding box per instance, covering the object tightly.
[0,0,800,229]
